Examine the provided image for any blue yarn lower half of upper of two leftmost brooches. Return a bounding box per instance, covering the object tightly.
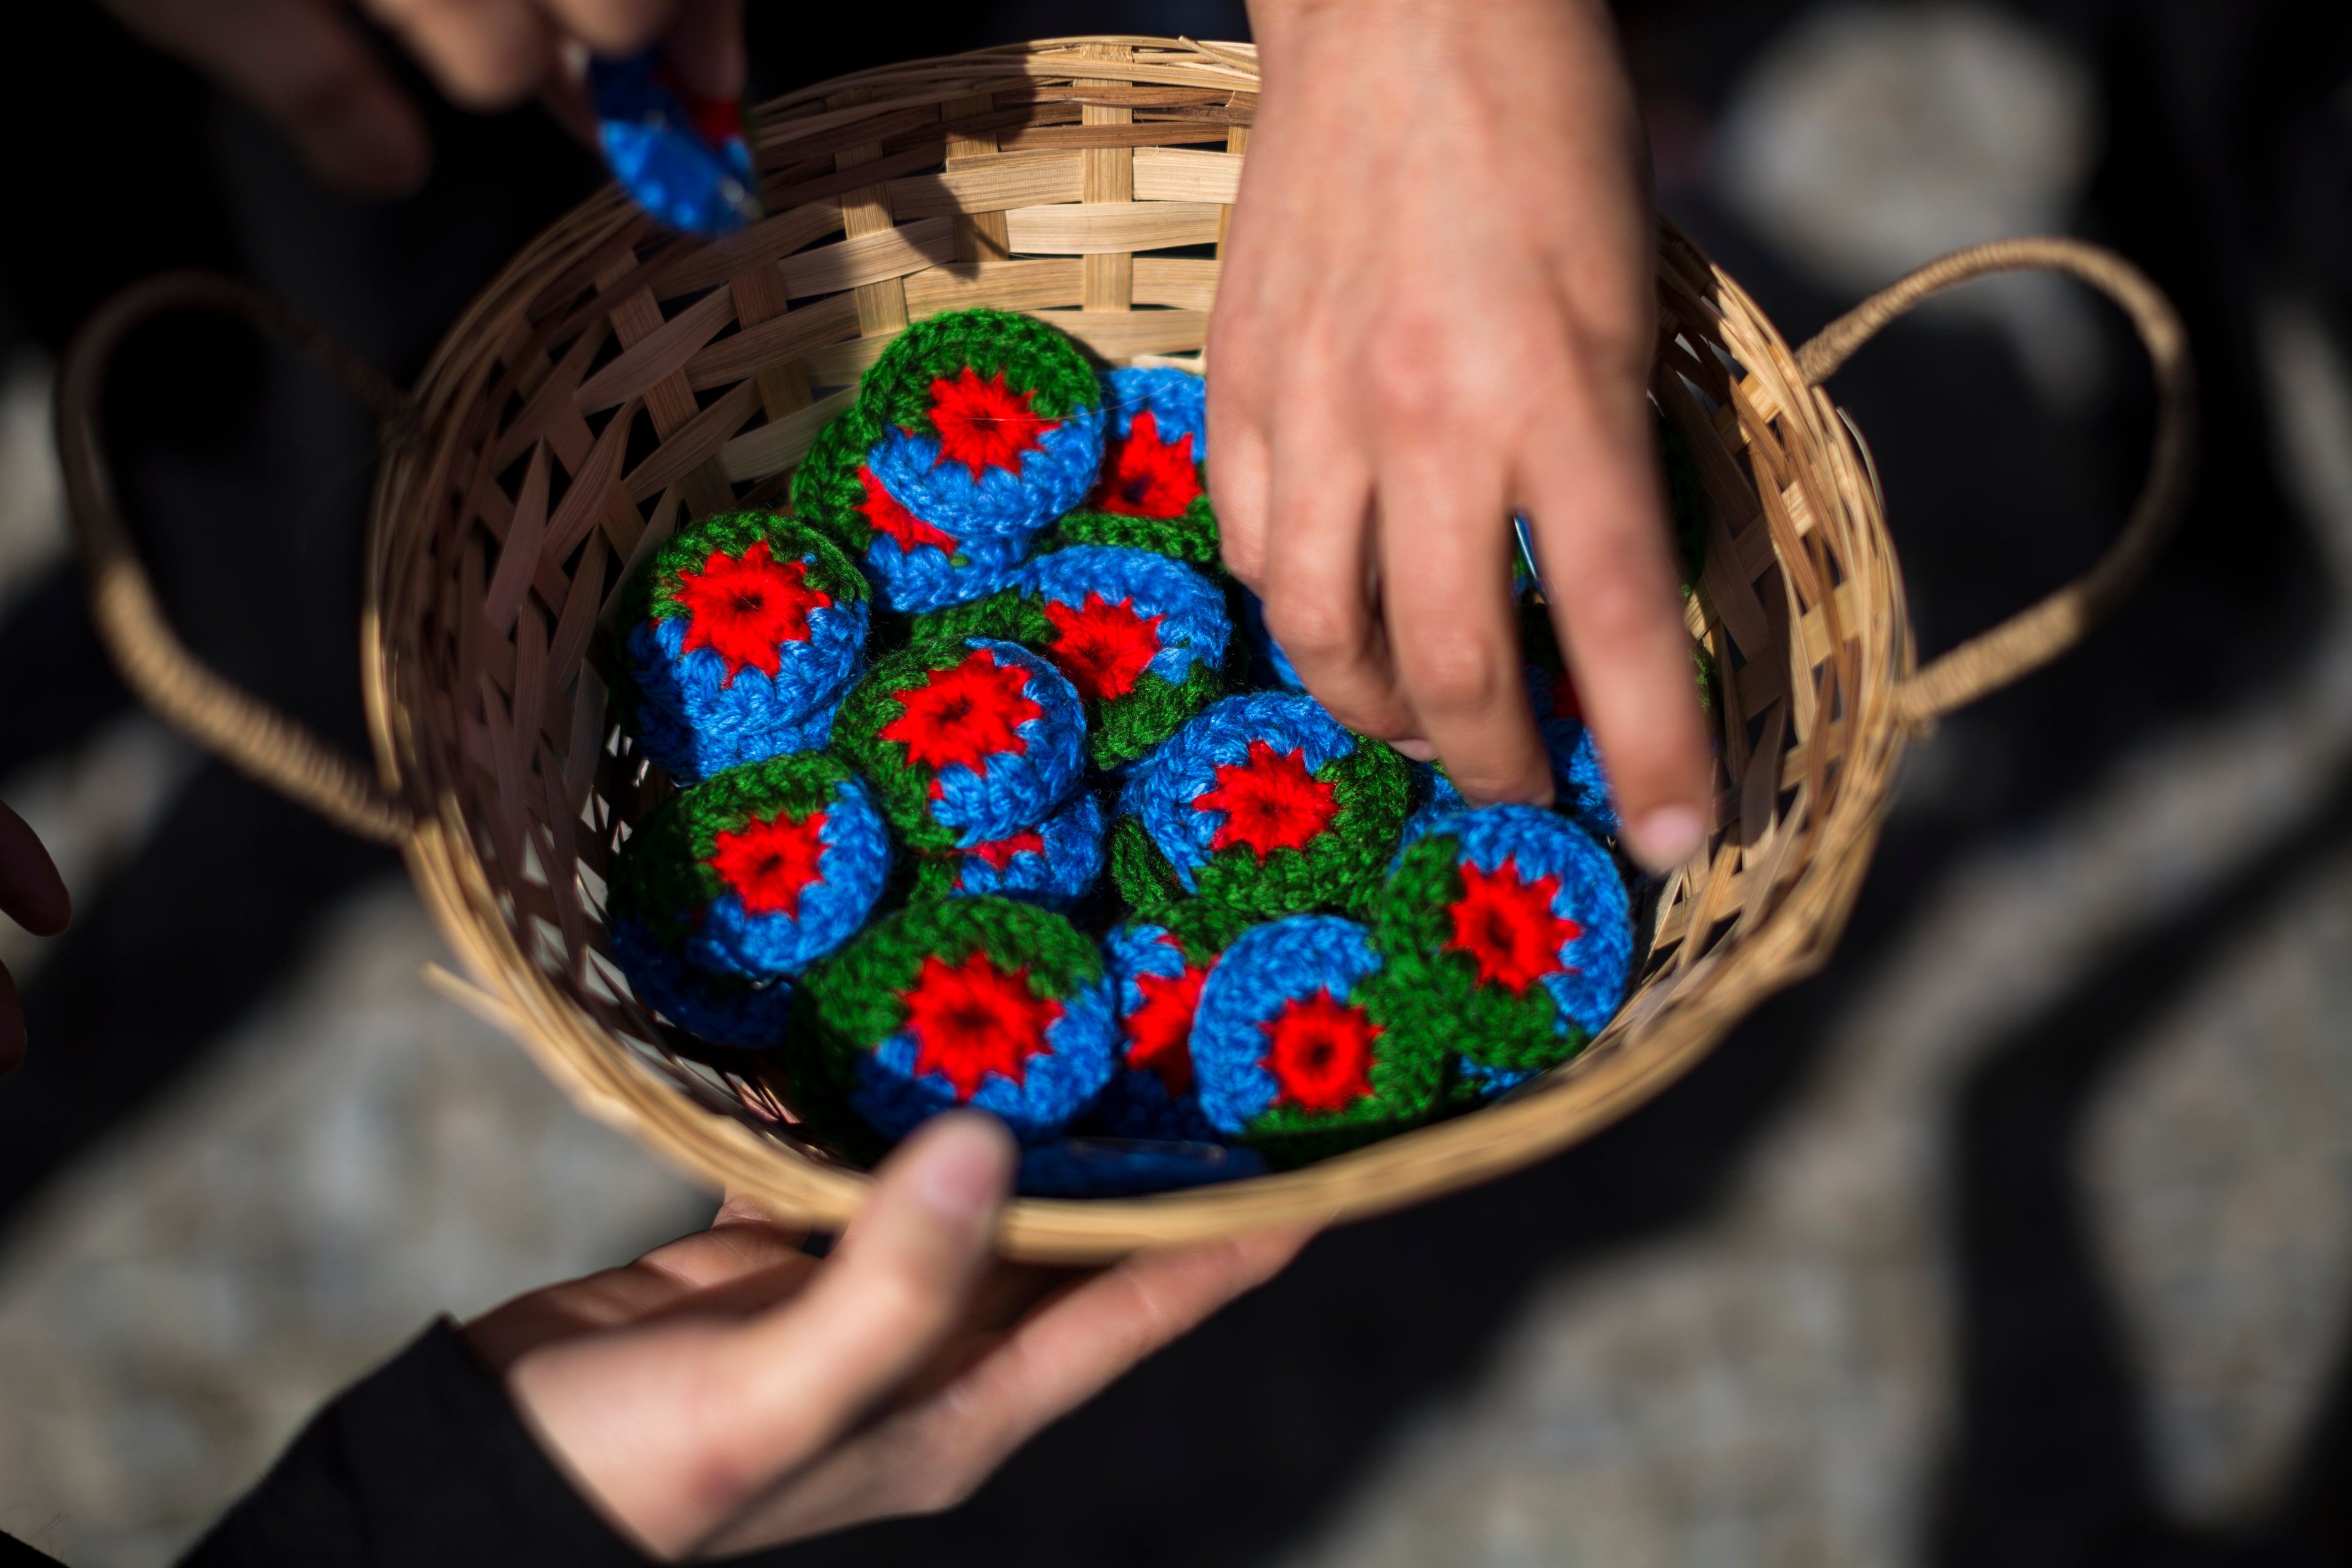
[628,588,870,783]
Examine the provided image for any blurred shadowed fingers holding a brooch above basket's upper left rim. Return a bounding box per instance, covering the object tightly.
[101,0,743,198]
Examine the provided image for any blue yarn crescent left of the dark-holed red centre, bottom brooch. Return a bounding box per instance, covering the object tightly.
[1192,915,1381,1136]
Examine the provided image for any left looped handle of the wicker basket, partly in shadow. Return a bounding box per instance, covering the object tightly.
[56,273,416,844]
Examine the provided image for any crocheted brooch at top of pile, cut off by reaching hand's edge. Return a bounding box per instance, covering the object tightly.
[1056,367,1218,566]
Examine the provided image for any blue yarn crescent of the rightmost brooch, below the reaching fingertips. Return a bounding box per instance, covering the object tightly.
[1446,806,1632,1035]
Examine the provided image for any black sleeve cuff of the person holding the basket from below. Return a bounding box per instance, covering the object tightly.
[181,1319,647,1568]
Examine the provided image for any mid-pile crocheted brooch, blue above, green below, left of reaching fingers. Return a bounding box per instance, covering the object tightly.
[915,545,1232,769]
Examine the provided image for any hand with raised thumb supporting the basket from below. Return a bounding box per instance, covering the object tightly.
[466,1112,1310,1561]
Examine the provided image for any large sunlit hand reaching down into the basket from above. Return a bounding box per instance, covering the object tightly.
[1209,0,1712,870]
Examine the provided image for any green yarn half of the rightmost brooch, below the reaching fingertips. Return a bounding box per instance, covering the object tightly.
[1357,830,1585,1105]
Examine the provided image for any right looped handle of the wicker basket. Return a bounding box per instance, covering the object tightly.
[1797,240,2197,726]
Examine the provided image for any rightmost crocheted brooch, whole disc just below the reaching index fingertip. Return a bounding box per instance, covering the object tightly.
[1376,806,1632,1098]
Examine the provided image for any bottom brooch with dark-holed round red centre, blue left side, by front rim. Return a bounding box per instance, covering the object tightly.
[1192,915,1437,1152]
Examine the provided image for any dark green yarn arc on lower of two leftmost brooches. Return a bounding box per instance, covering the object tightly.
[607,752,854,947]
